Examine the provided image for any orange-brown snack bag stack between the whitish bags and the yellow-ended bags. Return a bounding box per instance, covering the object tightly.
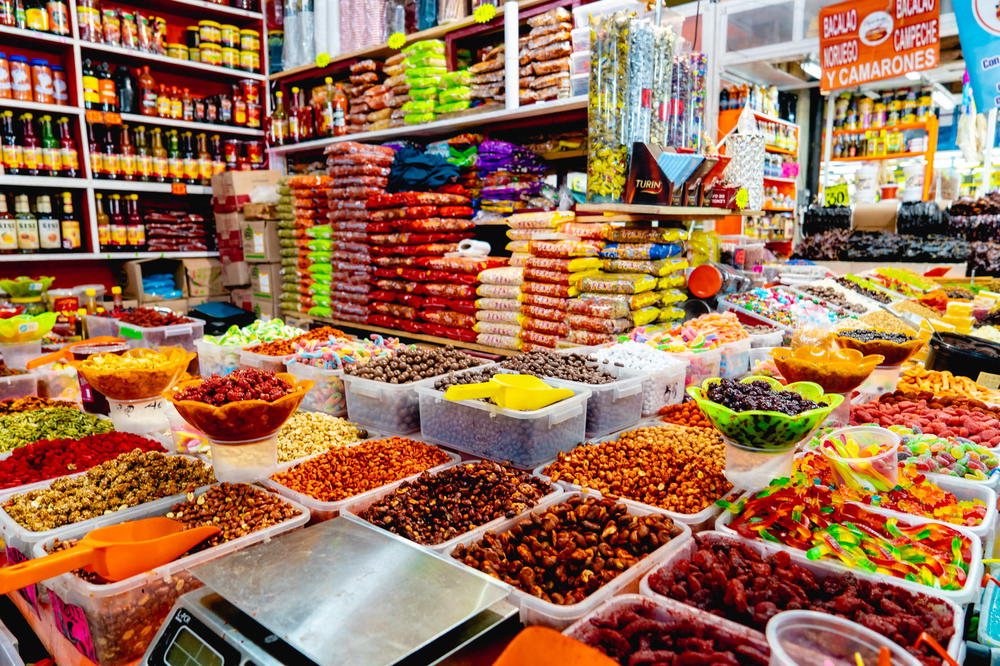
[521,239,601,351]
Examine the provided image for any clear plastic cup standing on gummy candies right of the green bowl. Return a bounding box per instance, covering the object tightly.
[818,426,900,492]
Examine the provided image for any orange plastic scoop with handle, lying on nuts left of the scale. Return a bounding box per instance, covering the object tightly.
[0,518,219,594]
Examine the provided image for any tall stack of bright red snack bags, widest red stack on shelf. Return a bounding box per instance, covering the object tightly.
[367,192,480,342]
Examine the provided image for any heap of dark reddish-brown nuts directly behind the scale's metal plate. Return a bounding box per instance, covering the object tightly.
[359,461,551,546]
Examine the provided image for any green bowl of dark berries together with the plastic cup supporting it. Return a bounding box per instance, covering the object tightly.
[688,376,844,488]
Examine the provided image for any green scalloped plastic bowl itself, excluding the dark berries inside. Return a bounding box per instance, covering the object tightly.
[688,376,844,449]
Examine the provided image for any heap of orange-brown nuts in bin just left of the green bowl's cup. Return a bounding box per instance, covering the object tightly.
[545,425,732,514]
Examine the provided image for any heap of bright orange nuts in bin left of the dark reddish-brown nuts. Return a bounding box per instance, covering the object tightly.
[271,437,449,502]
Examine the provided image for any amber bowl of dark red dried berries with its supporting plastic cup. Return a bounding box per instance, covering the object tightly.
[163,368,313,482]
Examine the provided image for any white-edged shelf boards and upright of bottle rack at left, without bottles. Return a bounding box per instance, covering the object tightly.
[0,0,267,263]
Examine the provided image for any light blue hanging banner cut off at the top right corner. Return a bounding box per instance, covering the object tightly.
[953,0,1000,113]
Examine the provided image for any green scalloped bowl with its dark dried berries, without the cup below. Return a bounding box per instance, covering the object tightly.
[688,375,844,450]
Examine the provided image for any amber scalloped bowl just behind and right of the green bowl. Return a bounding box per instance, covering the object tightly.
[771,345,884,393]
